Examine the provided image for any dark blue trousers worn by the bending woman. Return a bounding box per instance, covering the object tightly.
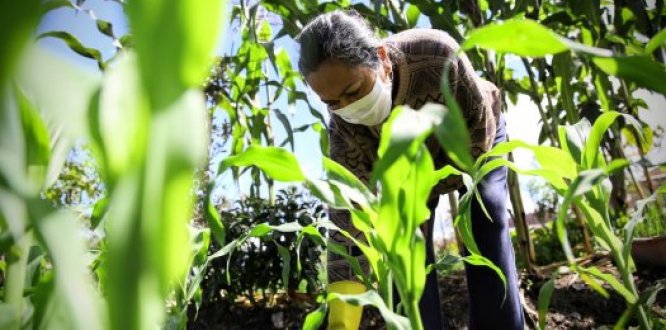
[419,117,525,329]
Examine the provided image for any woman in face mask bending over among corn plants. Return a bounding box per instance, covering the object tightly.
[297,11,524,329]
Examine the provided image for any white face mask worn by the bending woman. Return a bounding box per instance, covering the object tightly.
[333,73,392,126]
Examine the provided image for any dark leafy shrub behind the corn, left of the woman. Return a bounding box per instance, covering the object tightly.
[202,187,324,304]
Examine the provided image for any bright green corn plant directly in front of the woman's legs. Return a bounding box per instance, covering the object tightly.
[211,69,506,329]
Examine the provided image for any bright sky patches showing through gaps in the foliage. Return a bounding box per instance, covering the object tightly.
[38,0,666,241]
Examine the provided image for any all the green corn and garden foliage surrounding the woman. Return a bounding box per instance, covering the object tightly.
[0,0,666,329]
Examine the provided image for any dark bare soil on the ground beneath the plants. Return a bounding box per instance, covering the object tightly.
[188,258,666,329]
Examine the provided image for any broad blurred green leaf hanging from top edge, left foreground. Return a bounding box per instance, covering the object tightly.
[125,0,224,111]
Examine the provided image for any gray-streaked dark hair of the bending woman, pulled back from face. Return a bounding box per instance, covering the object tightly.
[296,10,382,76]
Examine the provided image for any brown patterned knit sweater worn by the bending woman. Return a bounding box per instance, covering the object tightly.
[328,29,500,281]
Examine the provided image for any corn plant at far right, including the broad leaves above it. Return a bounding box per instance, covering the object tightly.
[456,20,666,329]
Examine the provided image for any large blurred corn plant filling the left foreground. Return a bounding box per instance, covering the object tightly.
[0,0,223,329]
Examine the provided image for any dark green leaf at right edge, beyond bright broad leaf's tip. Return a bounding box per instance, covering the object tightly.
[592,56,666,95]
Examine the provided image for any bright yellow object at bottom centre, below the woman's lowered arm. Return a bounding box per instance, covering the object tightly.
[328,281,366,330]
